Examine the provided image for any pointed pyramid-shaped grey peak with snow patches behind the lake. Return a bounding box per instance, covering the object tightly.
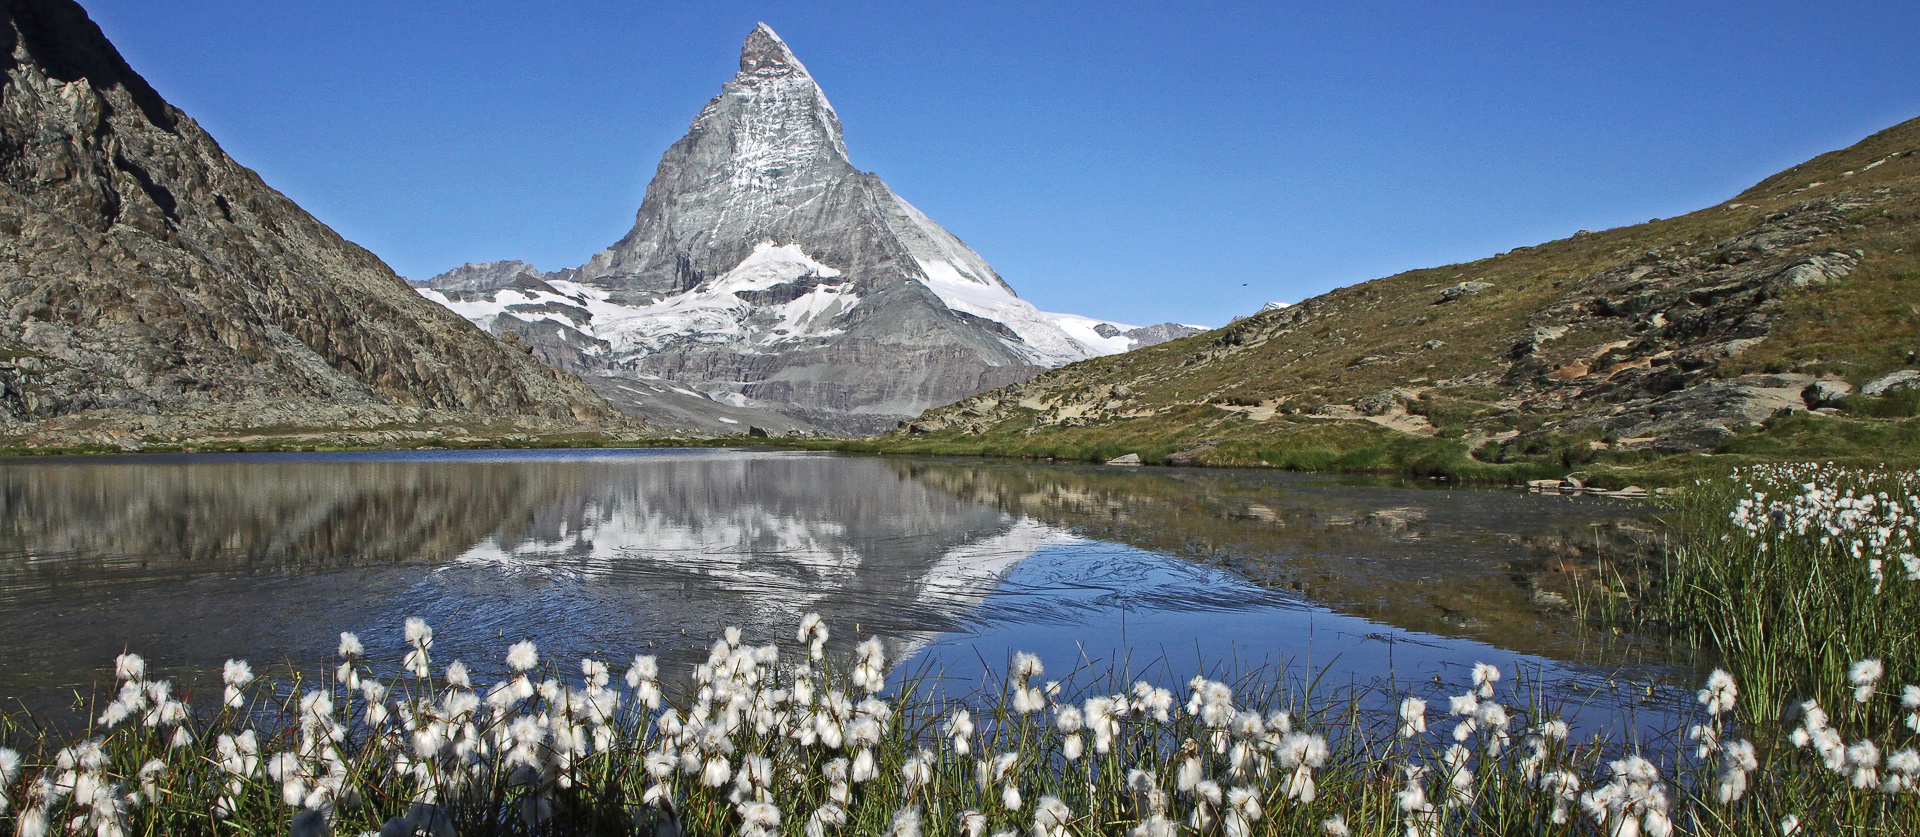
[420,23,1182,432]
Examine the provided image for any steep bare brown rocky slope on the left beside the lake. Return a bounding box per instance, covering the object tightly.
[0,0,618,451]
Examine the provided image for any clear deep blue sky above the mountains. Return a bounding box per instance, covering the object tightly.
[83,0,1920,324]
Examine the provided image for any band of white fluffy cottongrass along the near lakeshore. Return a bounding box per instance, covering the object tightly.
[0,614,1920,837]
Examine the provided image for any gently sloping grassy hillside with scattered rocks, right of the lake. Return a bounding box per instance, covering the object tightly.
[881,114,1920,478]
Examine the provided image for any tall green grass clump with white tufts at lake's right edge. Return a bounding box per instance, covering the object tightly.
[1649,463,1920,720]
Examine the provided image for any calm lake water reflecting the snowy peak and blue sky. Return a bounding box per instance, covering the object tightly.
[0,449,1697,722]
